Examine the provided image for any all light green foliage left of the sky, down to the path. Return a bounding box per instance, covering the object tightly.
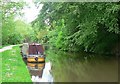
[2,2,35,45]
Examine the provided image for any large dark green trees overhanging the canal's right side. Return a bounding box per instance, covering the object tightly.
[32,2,120,53]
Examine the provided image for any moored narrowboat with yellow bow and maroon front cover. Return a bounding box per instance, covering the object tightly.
[21,43,45,62]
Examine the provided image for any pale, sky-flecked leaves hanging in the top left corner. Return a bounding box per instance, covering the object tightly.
[2,1,25,21]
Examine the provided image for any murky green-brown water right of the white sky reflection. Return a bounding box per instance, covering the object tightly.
[47,50,118,82]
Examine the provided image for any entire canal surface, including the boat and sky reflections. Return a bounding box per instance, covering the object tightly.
[23,49,118,82]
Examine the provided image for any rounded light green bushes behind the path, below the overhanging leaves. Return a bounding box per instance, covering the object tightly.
[2,18,34,45]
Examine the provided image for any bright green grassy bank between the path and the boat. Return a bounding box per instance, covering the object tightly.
[2,46,32,82]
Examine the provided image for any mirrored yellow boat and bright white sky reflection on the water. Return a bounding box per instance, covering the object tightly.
[27,62,53,83]
